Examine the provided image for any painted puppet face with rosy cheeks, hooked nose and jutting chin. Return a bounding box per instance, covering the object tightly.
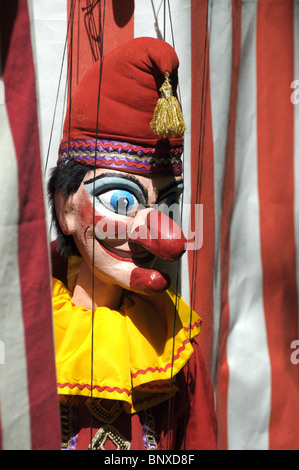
[56,169,186,293]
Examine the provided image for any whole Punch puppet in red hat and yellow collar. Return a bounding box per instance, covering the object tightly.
[48,38,216,450]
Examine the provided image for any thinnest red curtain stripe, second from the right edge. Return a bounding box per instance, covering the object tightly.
[216,0,242,449]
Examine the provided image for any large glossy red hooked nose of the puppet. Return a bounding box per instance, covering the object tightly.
[129,209,186,261]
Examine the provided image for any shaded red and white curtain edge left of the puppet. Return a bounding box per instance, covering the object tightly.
[0,0,60,450]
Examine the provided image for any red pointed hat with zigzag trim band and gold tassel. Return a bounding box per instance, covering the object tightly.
[58,37,185,174]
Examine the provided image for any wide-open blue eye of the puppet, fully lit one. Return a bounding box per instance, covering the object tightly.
[97,189,139,216]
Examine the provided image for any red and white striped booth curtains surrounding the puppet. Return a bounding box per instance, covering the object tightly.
[0,0,299,450]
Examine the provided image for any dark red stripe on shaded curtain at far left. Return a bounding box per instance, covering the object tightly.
[1,0,60,449]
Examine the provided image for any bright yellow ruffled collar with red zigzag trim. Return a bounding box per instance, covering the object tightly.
[53,278,201,413]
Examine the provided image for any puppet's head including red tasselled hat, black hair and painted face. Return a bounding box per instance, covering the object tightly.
[49,38,189,300]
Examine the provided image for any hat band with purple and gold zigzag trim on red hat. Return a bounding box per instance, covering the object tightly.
[57,139,183,175]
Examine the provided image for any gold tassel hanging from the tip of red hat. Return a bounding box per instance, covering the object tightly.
[150,72,186,139]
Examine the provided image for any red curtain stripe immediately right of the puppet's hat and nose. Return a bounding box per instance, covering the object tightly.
[188,0,215,368]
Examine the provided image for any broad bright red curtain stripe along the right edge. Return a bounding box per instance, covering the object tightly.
[257,0,299,449]
